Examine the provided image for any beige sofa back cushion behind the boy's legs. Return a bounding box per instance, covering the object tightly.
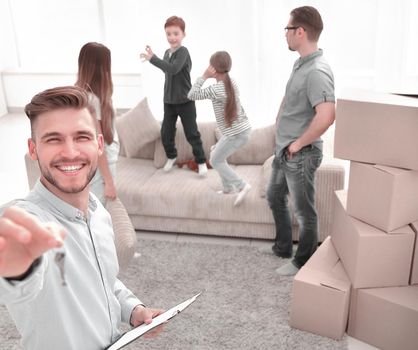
[154,122,216,168]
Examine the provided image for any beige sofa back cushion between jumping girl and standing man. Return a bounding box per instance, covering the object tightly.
[216,124,276,165]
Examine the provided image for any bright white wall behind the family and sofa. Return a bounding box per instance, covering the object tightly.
[0,0,418,121]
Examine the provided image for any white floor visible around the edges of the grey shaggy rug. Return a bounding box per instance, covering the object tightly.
[0,113,377,350]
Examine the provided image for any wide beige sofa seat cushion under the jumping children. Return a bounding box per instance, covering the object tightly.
[131,165,273,226]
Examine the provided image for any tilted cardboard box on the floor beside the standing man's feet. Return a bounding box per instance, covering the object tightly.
[289,236,351,339]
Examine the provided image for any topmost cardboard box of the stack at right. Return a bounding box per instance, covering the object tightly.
[334,90,418,170]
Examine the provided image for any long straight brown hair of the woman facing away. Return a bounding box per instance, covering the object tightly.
[75,42,115,145]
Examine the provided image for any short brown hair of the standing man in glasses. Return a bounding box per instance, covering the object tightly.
[290,6,324,42]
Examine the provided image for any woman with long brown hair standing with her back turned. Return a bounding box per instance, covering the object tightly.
[75,42,119,205]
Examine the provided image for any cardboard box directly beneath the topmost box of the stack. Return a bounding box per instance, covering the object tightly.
[347,162,418,232]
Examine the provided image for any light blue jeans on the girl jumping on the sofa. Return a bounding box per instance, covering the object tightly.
[210,129,251,192]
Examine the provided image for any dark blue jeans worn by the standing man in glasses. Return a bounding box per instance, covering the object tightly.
[267,145,322,268]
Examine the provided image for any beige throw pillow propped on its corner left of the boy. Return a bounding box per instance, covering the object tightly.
[116,98,160,158]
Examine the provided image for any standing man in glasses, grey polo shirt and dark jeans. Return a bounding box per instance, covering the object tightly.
[267,6,335,276]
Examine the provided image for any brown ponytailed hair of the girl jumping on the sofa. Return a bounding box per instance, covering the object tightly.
[210,51,238,127]
